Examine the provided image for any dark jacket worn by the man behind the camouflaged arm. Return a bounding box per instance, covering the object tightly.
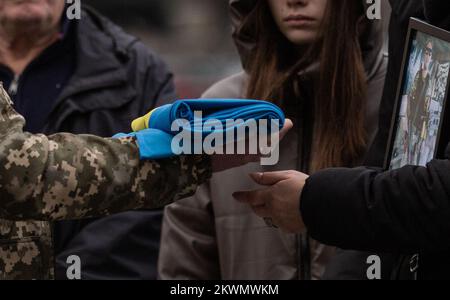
[44,8,175,279]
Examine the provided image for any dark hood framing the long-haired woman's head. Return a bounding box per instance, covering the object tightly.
[229,0,384,78]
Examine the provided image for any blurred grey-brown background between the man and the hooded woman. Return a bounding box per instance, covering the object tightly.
[85,0,390,98]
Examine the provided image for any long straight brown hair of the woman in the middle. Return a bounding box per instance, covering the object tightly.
[244,0,367,171]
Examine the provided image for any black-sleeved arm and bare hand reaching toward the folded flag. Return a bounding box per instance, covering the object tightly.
[235,150,450,279]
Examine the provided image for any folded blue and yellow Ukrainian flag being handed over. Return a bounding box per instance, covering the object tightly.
[115,99,285,159]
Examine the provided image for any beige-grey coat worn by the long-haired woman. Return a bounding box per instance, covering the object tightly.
[158,0,387,280]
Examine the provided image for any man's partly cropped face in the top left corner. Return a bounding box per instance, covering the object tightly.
[0,0,65,27]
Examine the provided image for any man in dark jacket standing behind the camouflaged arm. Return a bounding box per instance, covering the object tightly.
[0,0,175,279]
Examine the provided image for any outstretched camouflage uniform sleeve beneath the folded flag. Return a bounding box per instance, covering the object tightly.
[0,84,211,221]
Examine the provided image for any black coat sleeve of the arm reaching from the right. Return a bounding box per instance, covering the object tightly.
[301,160,450,253]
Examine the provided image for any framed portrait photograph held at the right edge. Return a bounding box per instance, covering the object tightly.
[385,19,450,170]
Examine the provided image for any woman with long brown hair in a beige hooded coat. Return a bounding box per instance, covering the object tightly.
[159,0,386,279]
